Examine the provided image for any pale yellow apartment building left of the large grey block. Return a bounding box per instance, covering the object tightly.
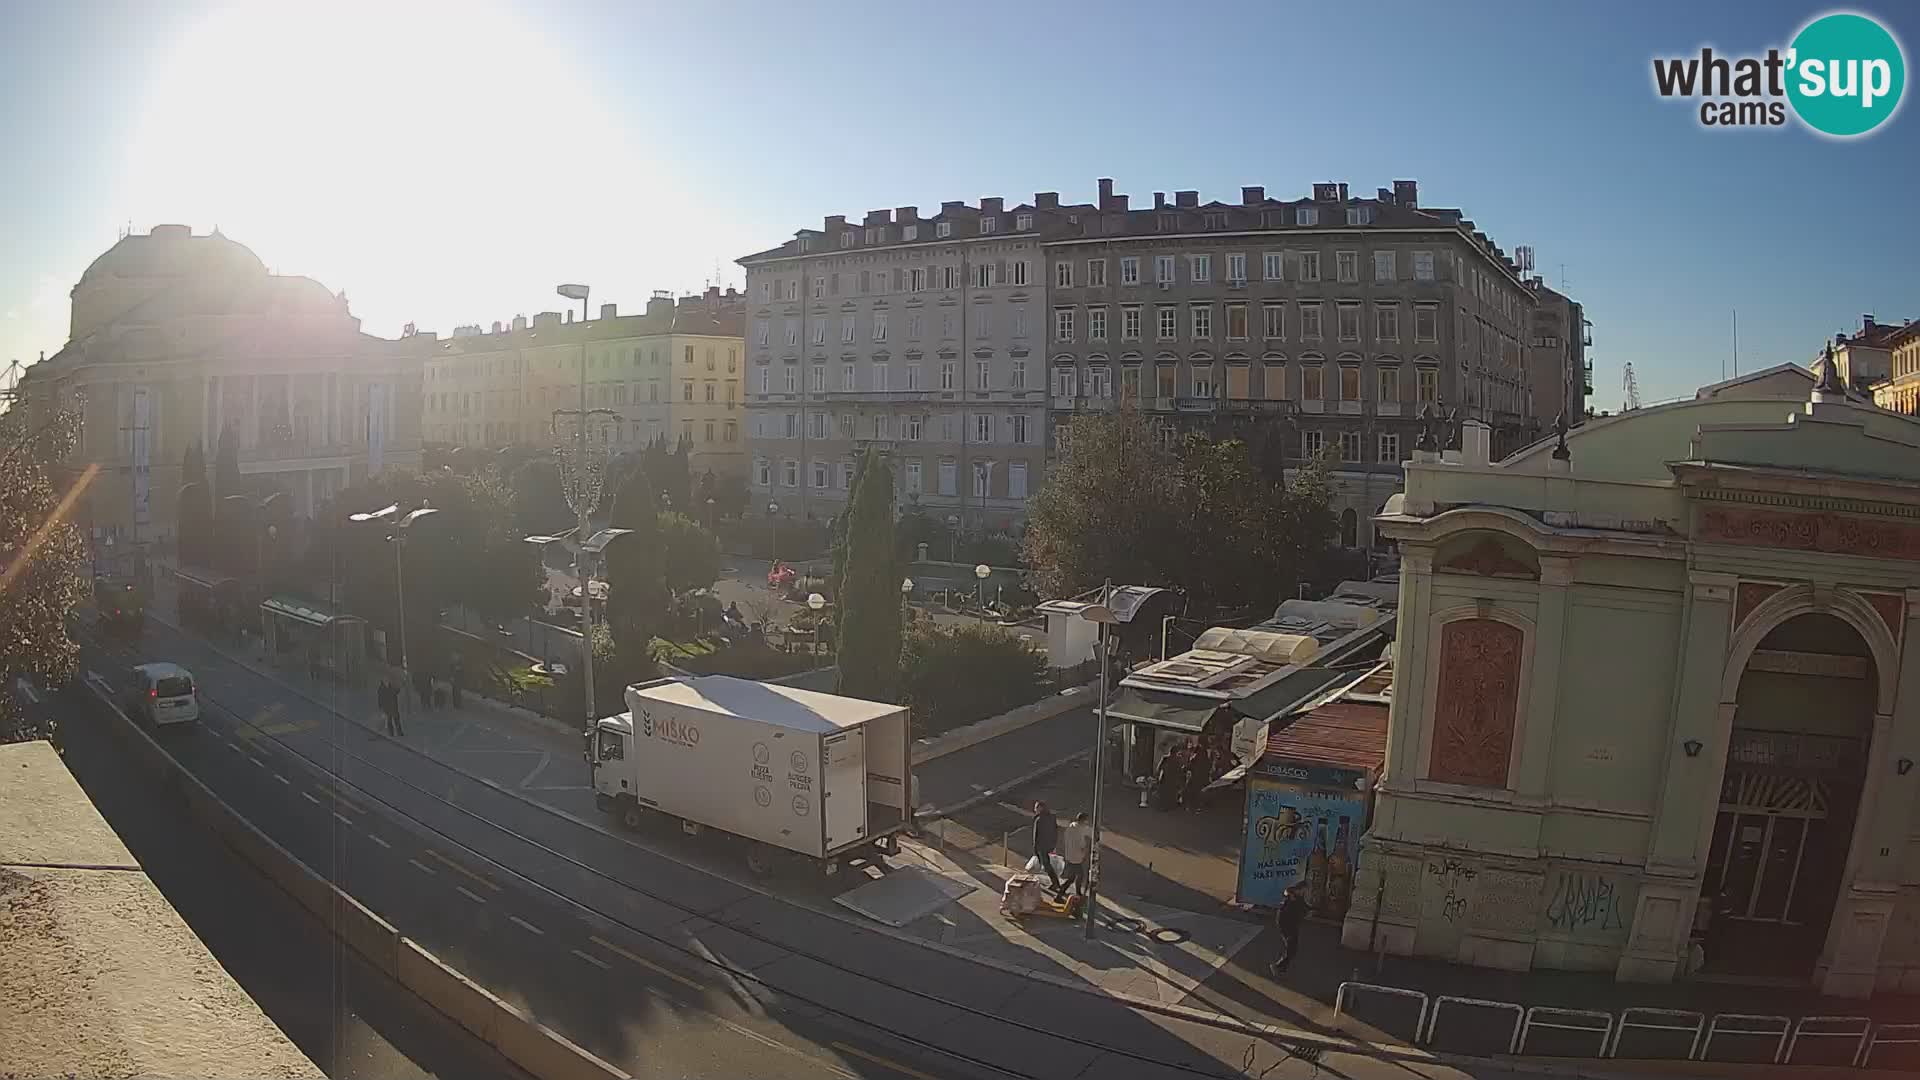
[422,288,747,477]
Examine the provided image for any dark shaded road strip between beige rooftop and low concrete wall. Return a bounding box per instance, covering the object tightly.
[46,688,526,1080]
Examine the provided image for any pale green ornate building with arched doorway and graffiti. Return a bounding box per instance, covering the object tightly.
[1344,365,1920,997]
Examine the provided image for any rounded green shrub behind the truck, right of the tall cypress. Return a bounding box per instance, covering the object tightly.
[900,621,1048,738]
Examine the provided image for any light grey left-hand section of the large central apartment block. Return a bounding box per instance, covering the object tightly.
[739,196,1058,530]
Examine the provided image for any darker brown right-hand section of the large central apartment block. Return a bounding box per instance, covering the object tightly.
[1046,179,1544,548]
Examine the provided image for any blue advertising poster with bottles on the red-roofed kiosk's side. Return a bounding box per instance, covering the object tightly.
[1240,776,1367,915]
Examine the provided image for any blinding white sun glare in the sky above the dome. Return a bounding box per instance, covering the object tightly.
[123,2,683,332]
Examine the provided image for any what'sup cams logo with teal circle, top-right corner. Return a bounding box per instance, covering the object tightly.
[1653,12,1907,138]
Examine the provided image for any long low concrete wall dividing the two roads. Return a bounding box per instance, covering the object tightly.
[88,682,632,1080]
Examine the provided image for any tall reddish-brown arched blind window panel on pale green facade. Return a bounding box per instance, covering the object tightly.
[1427,619,1524,788]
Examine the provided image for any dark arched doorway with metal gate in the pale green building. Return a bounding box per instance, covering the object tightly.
[1701,613,1878,978]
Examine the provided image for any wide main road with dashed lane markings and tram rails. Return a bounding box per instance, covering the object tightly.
[84,623,1482,1078]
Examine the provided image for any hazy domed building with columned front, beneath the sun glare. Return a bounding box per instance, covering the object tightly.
[27,225,424,564]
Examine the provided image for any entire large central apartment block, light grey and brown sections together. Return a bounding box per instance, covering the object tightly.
[739,179,1546,546]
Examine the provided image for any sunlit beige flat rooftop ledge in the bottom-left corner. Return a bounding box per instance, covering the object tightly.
[0,742,323,1080]
